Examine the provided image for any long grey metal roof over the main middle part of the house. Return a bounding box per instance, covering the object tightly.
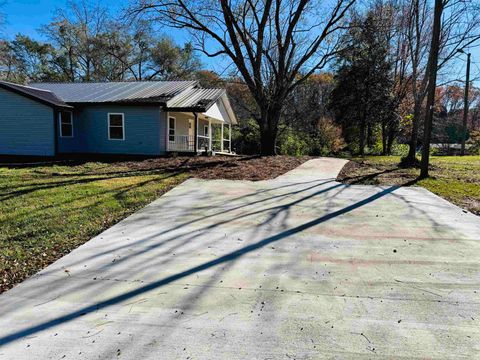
[30,81,197,103]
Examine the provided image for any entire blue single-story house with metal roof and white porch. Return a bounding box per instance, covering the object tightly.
[0,81,237,156]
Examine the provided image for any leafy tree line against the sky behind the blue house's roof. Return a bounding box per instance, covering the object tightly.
[0,2,201,82]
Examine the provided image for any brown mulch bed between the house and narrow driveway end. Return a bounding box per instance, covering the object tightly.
[117,156,311,181]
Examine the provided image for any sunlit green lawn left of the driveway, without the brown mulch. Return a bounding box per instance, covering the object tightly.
[0,162,189,292]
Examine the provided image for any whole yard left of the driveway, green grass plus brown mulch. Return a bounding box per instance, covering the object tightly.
[0,156,309,293]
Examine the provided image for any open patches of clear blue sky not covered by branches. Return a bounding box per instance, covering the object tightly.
[0,0,480,84]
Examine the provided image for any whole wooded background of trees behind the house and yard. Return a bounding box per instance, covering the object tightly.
[0,0,480,158]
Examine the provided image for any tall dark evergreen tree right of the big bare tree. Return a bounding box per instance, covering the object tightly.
[330,12,398,155]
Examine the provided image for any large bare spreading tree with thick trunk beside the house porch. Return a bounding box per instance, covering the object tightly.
[130,0,356,155]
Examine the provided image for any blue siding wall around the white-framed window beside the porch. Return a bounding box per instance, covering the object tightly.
[58,105,166,155]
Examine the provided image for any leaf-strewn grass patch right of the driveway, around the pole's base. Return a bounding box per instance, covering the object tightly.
[339,156,480,215]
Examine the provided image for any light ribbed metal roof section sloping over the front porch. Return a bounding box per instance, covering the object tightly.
[166,88,225,111]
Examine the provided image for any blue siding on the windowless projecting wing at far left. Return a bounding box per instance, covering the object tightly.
[0,89,55,156]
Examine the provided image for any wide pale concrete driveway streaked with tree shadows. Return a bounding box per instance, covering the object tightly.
[0,158,480,359]
